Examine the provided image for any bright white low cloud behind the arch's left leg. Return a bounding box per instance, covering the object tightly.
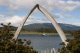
[0,15,49,26]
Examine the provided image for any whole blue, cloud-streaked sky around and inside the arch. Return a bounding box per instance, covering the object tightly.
[0,0,80,26]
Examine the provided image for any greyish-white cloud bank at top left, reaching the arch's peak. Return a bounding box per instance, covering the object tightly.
[0,0,35,10]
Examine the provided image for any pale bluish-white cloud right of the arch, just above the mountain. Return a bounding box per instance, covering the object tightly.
[56,14,80,26]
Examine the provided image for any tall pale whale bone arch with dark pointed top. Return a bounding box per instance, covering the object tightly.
[12,4,67,45]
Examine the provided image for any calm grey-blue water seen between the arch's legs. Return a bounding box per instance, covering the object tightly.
[18,34,71,51]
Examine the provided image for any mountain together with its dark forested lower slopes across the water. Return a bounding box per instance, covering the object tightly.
[0,23,80,32]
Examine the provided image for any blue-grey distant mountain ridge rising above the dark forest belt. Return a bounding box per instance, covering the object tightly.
[23,23,80,30]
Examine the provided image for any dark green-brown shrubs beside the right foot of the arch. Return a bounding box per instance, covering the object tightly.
[59,30,80,53]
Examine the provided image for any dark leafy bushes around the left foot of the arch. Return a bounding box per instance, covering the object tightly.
[0,23,38,53]
